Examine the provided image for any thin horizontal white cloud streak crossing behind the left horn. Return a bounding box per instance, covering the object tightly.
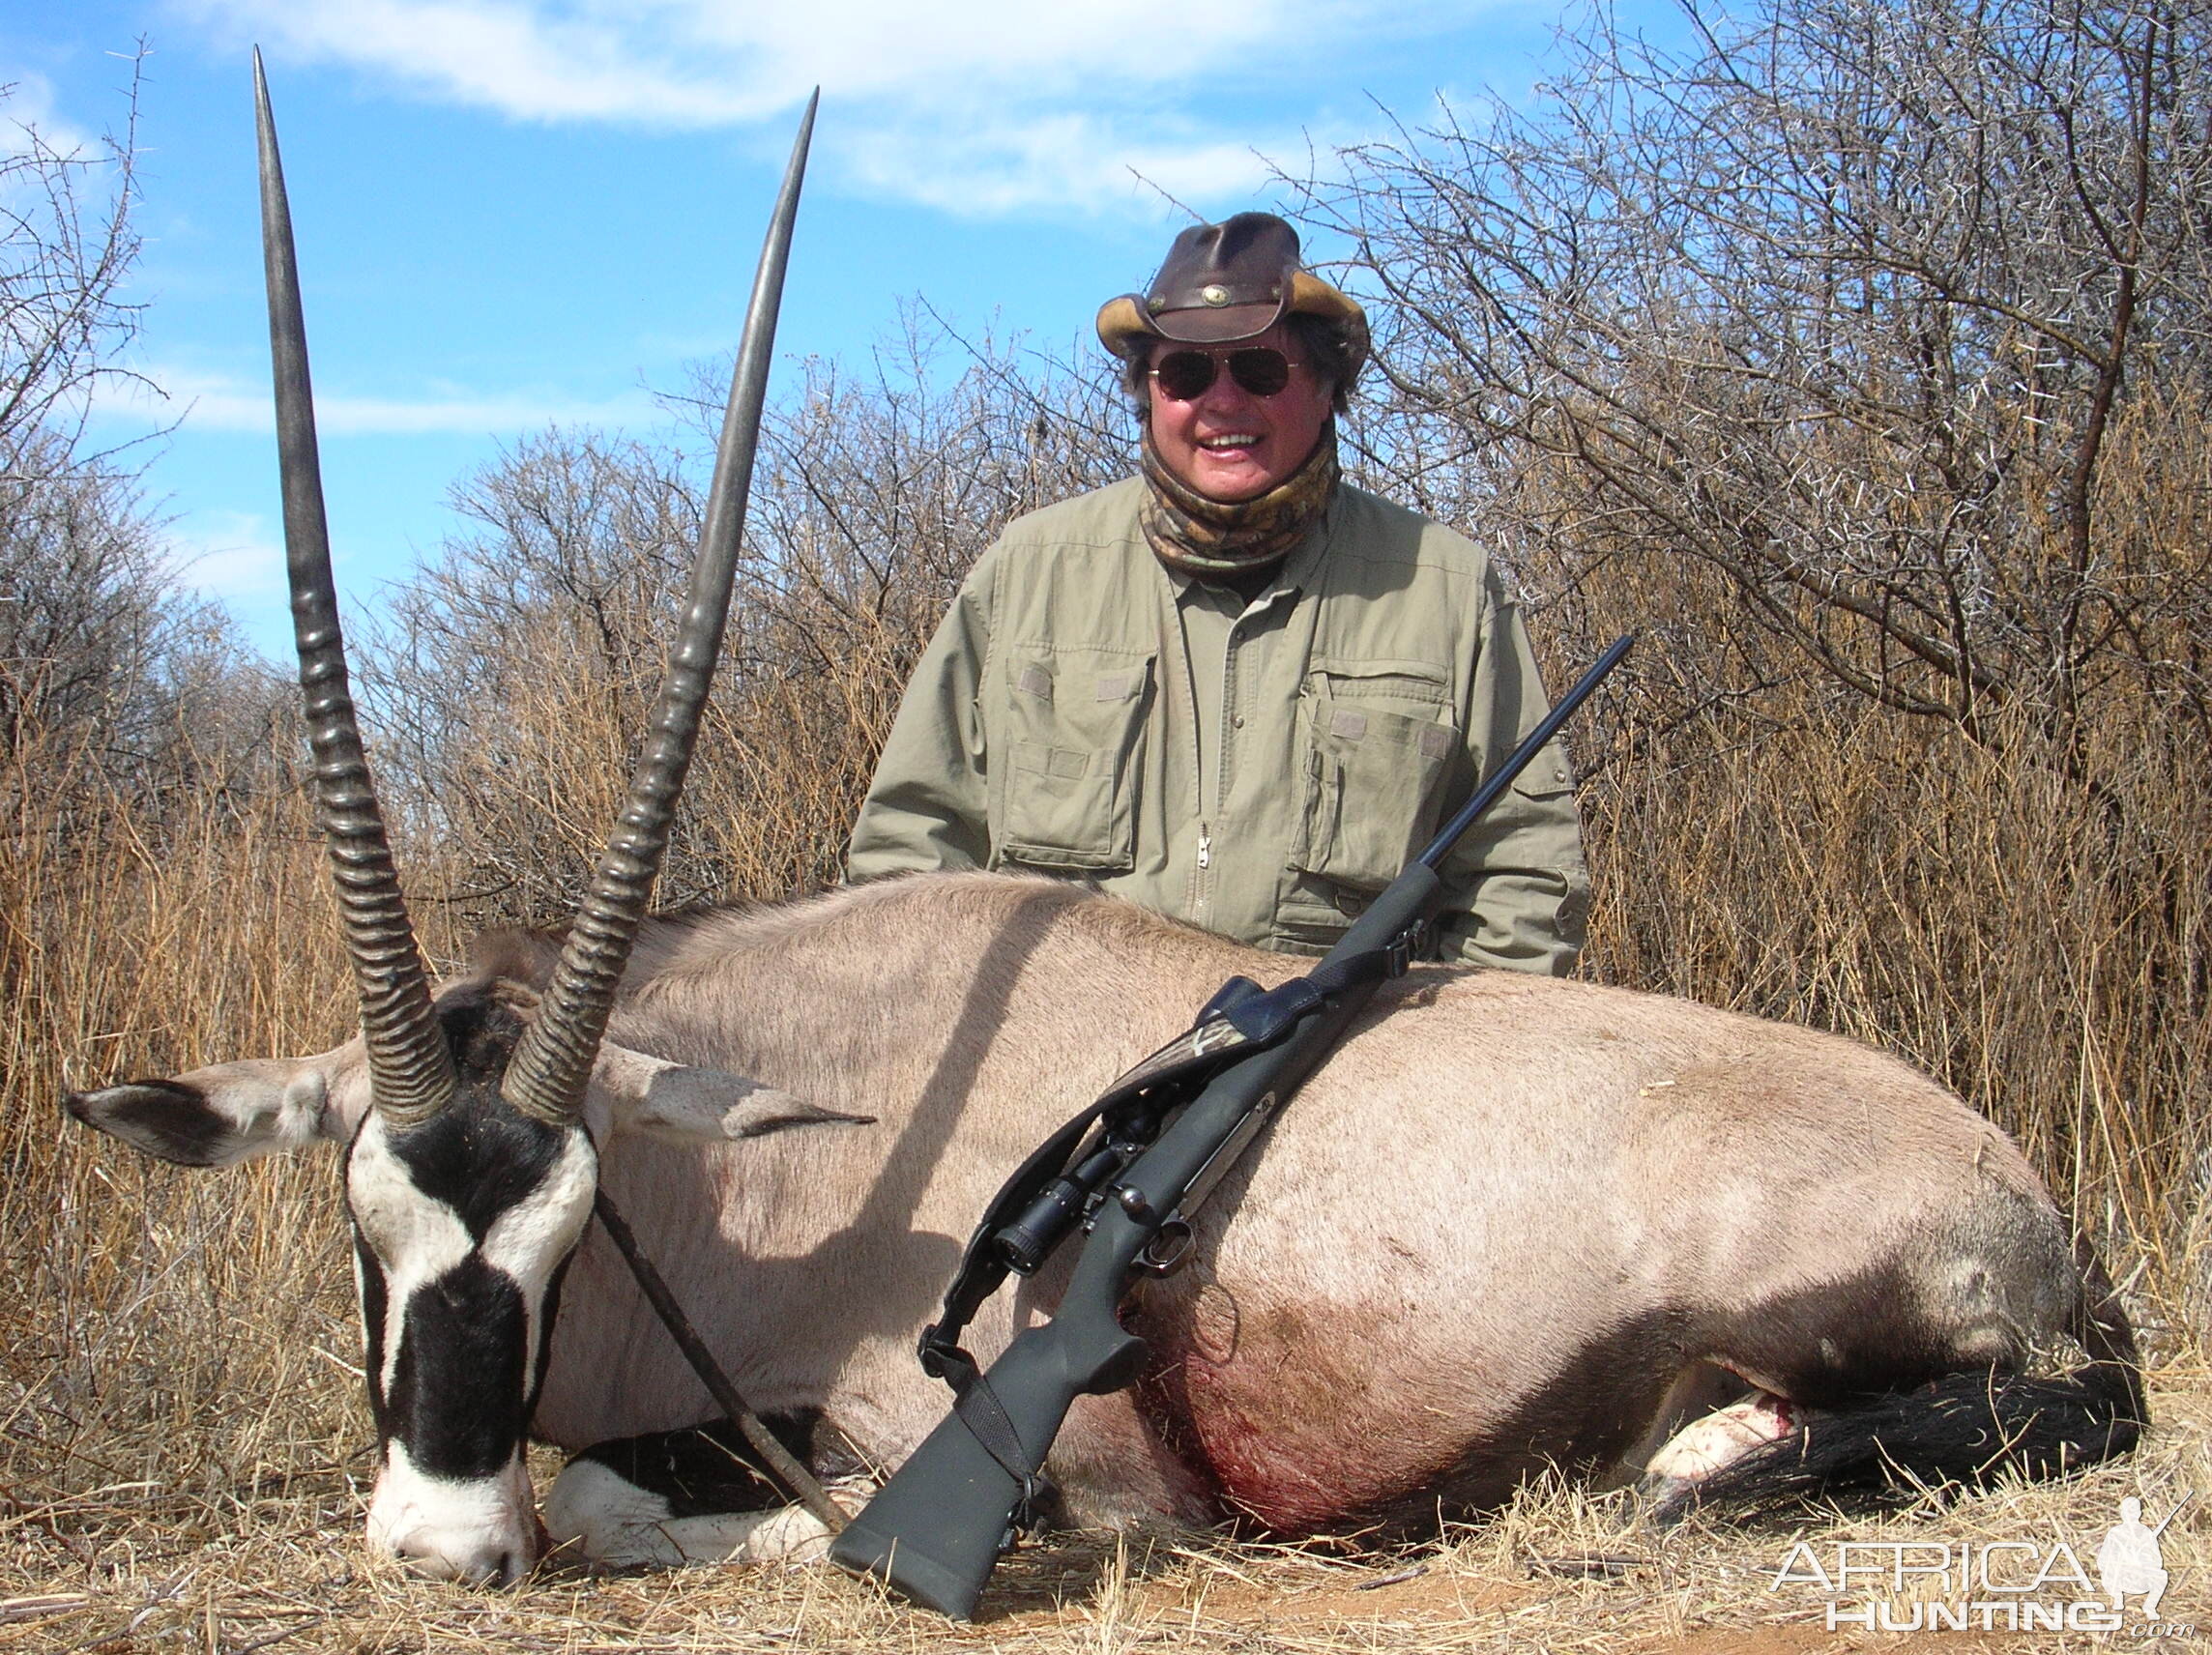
[100,367,659,436]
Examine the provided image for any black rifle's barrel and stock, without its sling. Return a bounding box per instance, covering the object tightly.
[830,635,1635,1619]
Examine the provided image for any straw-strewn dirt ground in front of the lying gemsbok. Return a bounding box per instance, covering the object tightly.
[0,1367,2212,1655]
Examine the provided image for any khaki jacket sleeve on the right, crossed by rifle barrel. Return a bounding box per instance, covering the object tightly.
[1438,575,1590,975]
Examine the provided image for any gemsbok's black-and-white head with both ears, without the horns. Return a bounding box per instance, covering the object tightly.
[64,980,856,1584]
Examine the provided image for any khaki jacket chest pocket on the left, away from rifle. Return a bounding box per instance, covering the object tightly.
[993,654,1152,874]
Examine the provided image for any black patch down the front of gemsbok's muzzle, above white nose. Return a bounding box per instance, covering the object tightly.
[385,1255,529,1478]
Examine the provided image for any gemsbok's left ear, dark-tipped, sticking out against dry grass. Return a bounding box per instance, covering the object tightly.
[62,1047,347,1166]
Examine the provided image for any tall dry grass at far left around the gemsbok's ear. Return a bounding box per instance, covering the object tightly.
[0,734,385,1646]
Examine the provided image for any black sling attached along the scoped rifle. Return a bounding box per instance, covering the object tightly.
[920,936,1415,1526]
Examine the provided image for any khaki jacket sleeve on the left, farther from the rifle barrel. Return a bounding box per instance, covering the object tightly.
[845,565,991,883]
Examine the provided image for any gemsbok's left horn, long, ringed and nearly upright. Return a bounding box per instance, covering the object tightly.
[254,48,453,1124]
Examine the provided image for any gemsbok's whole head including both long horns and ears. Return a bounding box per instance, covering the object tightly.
[67,53,823,1582]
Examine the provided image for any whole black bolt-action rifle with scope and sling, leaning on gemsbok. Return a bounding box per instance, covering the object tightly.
[830,635,1635,1619]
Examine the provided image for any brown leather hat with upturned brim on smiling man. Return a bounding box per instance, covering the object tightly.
[1097,213,1367,372]
